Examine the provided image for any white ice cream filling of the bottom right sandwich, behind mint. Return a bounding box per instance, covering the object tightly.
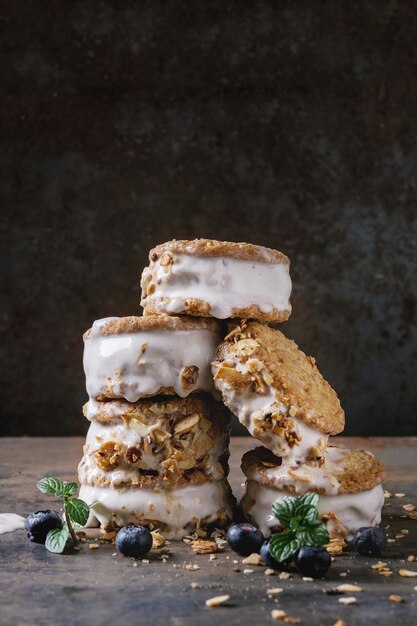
[242,480,384,539]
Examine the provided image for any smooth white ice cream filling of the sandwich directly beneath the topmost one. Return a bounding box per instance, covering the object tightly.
[84,318,221,402]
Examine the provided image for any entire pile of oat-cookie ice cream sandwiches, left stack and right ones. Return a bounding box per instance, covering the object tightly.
[79,239,384,537]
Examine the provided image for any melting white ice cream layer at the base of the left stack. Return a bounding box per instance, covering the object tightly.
[79,481,231,539]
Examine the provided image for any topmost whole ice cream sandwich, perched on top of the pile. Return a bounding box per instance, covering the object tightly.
[141,239,291,322]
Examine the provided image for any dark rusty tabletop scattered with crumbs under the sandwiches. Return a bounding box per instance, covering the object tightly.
[0,437,417,626]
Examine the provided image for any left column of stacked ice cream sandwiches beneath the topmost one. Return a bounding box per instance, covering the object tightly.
[79,315,232,537]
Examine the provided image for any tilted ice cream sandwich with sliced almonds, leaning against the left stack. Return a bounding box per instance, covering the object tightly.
[212,322,344,463]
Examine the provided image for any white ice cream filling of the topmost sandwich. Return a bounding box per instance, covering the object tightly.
[144,252,291,319]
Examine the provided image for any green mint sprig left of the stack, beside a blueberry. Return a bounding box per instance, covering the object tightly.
[37,476,94,554]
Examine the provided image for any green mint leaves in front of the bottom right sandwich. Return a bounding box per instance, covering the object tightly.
[269,492,330,563]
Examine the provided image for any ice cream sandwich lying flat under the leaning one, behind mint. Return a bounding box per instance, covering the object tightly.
[242,447,386,539]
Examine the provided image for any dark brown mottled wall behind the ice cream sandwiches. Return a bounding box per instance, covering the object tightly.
[0,0,417,435]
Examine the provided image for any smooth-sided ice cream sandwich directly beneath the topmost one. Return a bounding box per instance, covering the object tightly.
[84,316,222,402]
